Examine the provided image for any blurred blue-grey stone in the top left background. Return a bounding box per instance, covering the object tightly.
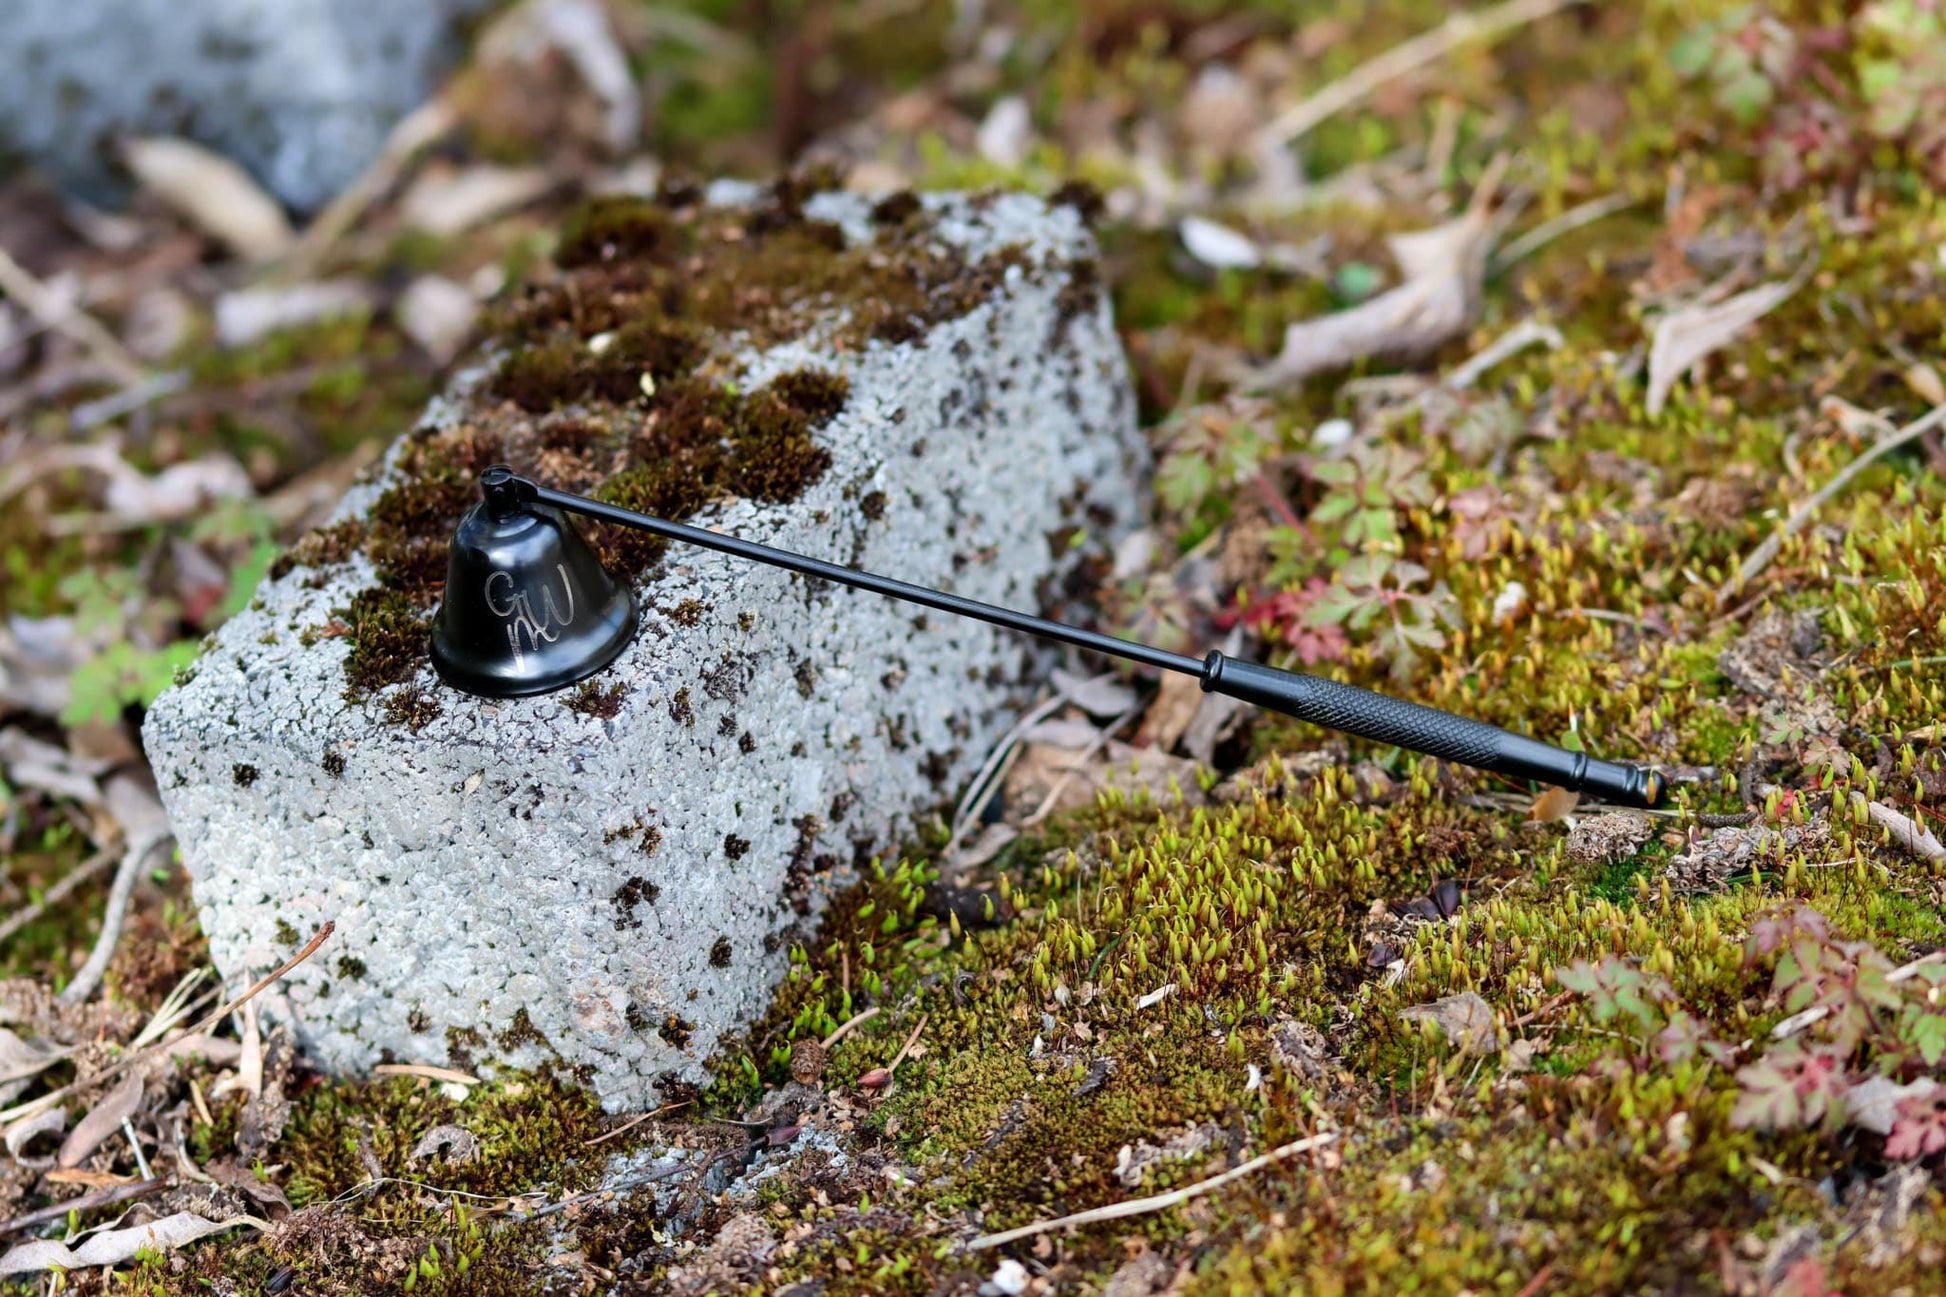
[0,0,487,208]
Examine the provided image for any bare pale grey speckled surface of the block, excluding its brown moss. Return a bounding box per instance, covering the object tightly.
[144,186,1146,1106]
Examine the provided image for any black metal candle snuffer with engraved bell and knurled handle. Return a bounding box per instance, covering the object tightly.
[432,463,1664,806]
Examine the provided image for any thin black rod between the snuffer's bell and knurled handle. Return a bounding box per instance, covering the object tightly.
[533,485,1203,680]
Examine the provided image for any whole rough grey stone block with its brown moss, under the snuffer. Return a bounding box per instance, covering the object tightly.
[144,185,1136,1110]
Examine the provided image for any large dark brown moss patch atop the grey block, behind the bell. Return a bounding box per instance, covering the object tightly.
[274,181,1074,724]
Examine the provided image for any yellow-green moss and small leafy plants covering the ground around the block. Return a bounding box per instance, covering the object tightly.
[0,0,1946,1297]
